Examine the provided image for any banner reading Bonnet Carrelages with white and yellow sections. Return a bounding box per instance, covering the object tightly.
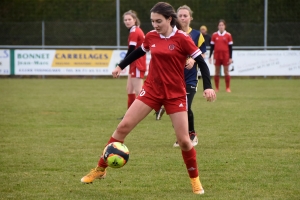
[15,50,126,75]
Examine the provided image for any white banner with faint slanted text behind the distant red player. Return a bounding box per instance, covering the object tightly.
[205,50,300,76]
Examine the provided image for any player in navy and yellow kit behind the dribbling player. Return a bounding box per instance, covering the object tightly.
[173,5,206,147]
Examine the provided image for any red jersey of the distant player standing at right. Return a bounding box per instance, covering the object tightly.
[210,31,233,53]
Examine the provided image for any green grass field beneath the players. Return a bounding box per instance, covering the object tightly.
[0,78,300,200]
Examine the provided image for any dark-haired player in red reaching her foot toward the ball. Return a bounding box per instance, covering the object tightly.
[81,2,216,194]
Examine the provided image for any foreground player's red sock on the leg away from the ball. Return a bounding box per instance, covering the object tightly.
[181,147,199,178]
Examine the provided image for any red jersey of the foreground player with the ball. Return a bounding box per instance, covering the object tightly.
[141,27,201,99]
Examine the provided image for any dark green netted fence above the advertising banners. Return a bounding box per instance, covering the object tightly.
[0,0,300,46]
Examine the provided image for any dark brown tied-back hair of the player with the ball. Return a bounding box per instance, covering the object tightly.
[150,2,182,30]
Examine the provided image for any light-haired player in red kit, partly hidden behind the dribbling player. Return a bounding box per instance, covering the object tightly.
[120,10,146,119]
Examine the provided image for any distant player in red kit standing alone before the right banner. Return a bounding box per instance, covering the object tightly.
[209,19,233,92]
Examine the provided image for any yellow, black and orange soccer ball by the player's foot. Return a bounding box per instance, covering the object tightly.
[103,142,129,168]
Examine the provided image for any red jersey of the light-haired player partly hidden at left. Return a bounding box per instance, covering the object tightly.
[128,26,146,71]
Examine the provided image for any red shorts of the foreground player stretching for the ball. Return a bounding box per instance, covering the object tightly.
[137,88,187,114]
